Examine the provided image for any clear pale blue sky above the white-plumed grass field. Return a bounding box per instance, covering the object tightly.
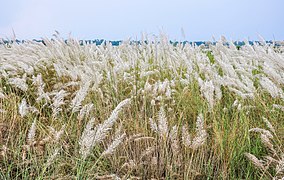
[0,0,284,41]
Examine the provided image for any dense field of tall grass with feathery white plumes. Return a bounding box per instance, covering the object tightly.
[0,35,284,179]
